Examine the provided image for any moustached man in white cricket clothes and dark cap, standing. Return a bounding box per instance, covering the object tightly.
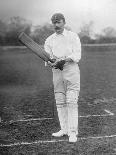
[44,13,81,142]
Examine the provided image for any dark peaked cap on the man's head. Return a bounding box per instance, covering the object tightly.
[51,13,65,23]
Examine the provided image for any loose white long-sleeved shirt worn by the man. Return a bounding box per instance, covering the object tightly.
[44,29,81,63]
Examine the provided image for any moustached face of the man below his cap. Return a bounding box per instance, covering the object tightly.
[52,19,65,34]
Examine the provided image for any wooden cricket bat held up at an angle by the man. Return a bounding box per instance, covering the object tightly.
[19,32,55,63]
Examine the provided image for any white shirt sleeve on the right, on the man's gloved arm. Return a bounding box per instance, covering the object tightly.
[68,33,81,63]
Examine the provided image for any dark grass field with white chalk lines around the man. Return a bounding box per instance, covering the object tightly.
[0,46,116,155]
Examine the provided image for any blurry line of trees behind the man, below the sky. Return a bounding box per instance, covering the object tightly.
[0,17,116,46]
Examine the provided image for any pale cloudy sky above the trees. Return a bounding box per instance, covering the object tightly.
[0,0,116,33]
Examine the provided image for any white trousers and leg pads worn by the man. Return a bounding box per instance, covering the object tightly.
[53,63,80,135]
